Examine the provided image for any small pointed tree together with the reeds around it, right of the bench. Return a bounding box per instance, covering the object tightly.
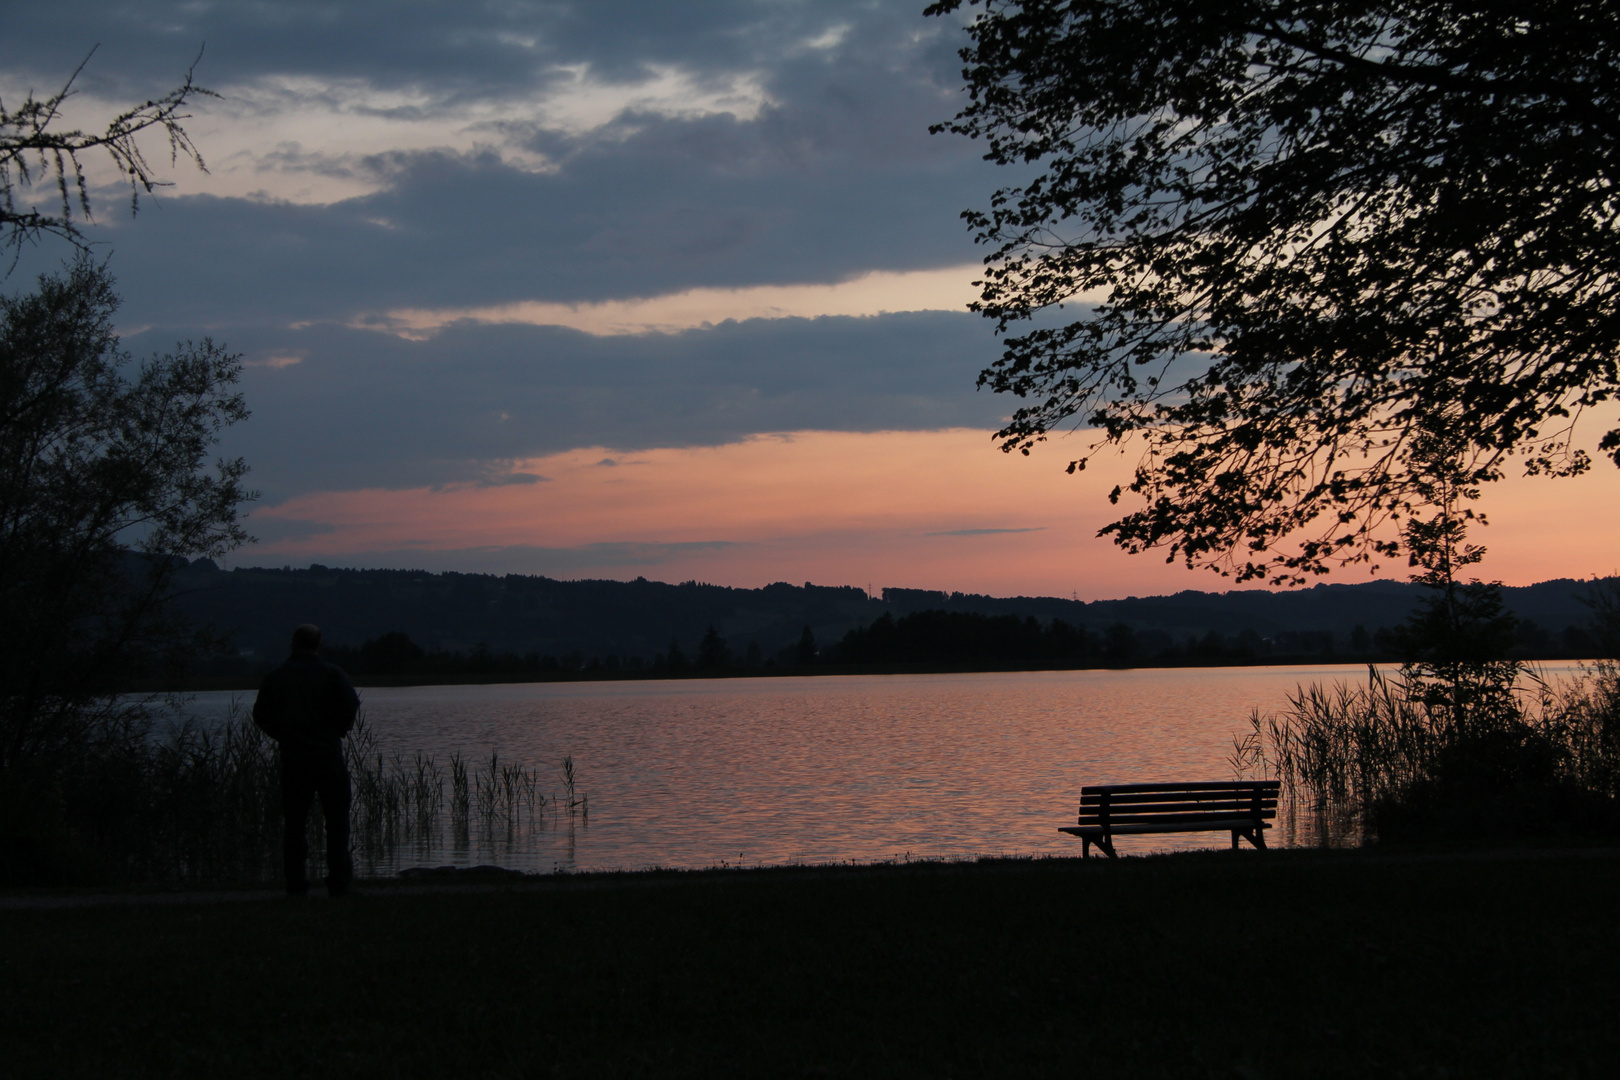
[1272,426,1620,842]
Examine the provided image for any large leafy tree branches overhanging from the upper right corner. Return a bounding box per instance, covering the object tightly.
[928,0,1620,581]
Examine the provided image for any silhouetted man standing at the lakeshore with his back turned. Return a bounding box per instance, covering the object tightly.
[253,623,360,895]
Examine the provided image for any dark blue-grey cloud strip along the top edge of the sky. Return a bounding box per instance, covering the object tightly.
[0,0,954,113]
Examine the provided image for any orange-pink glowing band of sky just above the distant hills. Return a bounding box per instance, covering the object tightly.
[233,429,1620,599]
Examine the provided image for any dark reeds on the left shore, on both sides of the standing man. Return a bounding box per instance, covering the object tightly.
[11,701,585,884]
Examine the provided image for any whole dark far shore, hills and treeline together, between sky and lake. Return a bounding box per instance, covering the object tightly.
[175,559,1596,682]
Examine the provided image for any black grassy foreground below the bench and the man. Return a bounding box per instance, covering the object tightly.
[0,852,1620,1078]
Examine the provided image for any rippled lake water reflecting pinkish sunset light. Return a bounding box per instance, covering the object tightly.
[177,665,1581,873]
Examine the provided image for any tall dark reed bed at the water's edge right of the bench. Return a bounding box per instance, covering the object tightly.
[1257,661,1620,845]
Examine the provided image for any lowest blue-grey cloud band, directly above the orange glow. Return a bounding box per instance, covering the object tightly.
[126,313,1006,502]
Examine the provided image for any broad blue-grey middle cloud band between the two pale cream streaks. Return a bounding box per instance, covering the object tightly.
[22,8,1004,325]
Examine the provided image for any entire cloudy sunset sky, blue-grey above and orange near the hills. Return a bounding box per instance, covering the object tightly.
[0,0,1620,599]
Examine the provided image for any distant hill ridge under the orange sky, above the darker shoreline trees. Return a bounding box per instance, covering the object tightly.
[164,559,1591,667]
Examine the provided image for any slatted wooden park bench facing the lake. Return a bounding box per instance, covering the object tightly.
[1058,780,1277,858]
